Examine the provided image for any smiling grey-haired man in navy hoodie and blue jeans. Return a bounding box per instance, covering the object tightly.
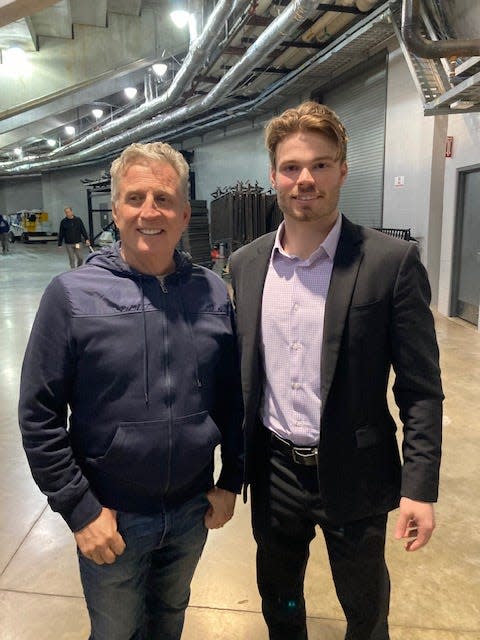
[19,142,243,640]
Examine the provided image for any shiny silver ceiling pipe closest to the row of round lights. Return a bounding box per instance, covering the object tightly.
[29,0,251,158]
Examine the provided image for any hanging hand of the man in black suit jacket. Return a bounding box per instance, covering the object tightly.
[395,498,435,551]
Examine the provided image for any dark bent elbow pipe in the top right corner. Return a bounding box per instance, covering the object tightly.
[402,0,480,58]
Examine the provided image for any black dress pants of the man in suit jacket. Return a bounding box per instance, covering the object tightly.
[251,440,390,640]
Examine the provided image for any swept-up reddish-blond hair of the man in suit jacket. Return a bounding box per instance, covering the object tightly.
[265,100,348,168]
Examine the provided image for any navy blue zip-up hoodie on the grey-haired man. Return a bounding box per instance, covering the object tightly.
[19,243,243,531]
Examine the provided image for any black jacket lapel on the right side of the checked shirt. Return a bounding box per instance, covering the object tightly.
[320,216,363,411]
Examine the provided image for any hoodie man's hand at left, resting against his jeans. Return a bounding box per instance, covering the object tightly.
[74,507,125,564]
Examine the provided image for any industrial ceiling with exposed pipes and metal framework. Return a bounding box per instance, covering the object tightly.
[0,0,480,176]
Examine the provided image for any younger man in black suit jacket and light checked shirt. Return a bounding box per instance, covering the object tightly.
[230,102,443,640]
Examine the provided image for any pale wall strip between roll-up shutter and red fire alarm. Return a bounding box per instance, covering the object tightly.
[383,49,448,304]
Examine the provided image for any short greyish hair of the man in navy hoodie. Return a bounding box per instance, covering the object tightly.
[110,142,189,203]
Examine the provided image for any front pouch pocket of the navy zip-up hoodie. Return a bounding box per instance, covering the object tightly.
[87,411,220,495]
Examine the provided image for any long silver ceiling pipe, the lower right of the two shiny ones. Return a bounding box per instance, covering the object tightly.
[0,0,318,175]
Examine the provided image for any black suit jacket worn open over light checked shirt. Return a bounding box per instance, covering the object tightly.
[231,217,443,522]
